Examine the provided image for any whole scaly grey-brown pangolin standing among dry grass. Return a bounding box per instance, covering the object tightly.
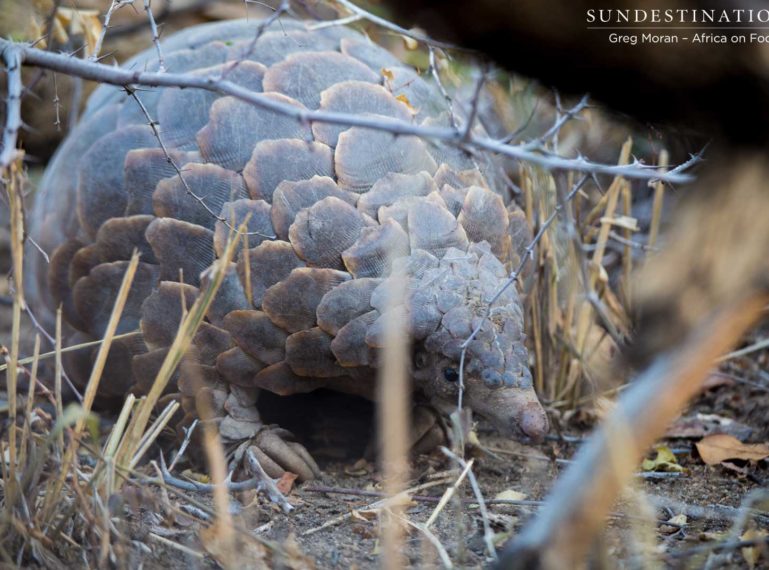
[26,19,547,479]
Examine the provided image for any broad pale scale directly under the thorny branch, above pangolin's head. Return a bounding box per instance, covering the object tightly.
[334,123,438,193]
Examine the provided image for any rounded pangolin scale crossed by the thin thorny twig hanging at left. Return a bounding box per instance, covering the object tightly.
[152,163,246,230]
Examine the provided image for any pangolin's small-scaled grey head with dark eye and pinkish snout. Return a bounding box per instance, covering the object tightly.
[374,242,548,441]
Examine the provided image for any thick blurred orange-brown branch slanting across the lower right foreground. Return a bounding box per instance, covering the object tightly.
[498,293,769,568]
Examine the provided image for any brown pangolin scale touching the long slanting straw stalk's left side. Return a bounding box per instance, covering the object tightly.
[141,281,198,349]
